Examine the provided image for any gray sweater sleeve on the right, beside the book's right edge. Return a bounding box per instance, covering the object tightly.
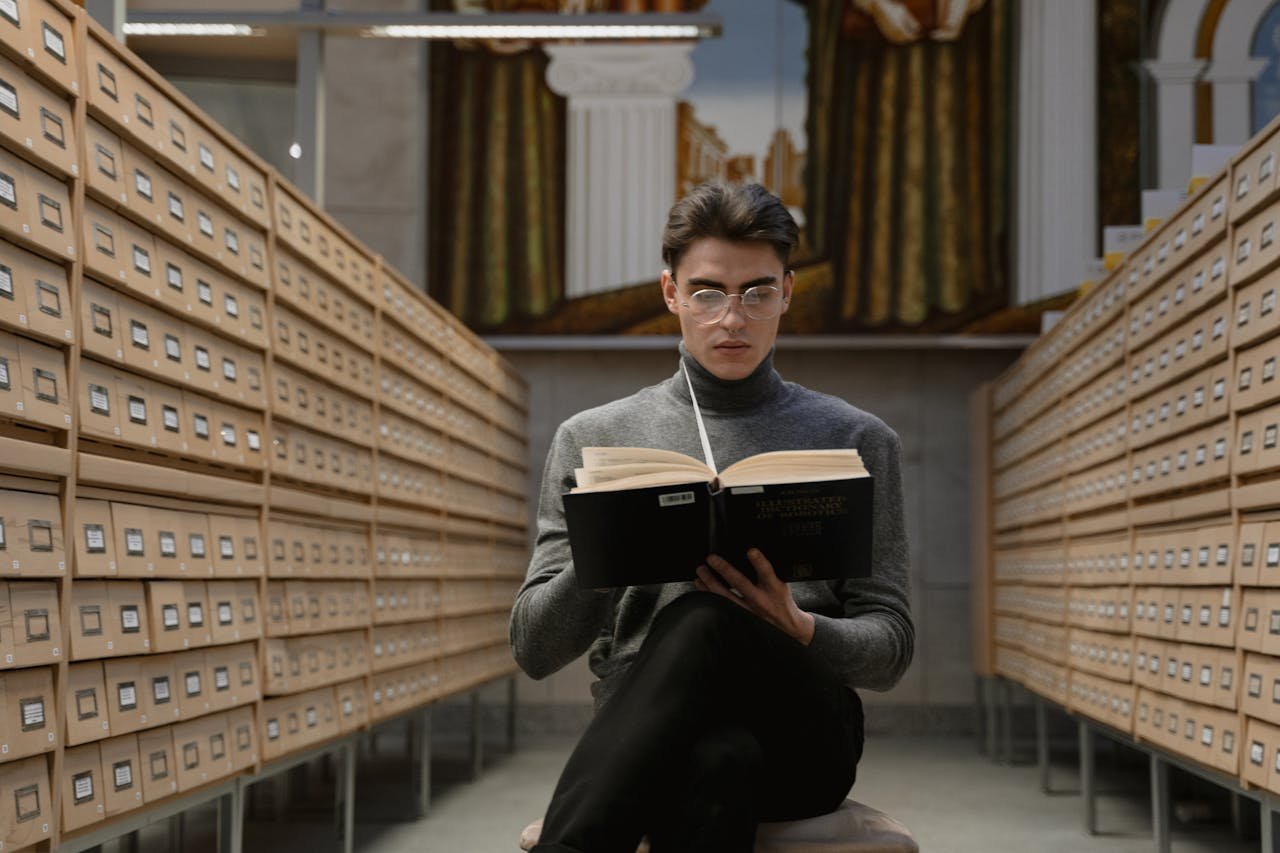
[809,425,915,690]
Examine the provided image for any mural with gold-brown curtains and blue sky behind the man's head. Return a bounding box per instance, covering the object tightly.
[428,0,1014,334]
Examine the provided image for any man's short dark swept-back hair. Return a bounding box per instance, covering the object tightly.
[662,182,800,273]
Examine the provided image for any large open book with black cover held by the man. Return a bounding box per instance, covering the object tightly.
[564,447,872,588]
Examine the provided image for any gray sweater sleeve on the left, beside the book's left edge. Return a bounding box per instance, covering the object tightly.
[511,424,613,679]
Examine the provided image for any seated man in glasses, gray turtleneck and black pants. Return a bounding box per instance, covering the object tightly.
[511,184,914,853]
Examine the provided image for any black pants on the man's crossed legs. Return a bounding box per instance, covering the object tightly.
[534,593,863,853]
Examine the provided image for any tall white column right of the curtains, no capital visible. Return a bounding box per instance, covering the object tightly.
[1016,0,1100,305]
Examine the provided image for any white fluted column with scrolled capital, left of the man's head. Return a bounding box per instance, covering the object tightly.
[545,44,694,298]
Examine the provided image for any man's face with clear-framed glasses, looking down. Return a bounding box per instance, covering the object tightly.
[662,237,792,379]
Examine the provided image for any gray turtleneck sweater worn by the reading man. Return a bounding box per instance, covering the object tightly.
[511,345,915,707]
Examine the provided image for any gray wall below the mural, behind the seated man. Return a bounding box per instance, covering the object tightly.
[499,334,1018,730]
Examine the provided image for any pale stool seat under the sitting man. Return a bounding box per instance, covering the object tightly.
[520,799,920,853]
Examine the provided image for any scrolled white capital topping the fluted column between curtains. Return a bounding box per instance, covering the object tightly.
[543,42,694,99]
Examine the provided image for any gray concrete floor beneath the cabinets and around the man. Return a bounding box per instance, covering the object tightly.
[122,733,1260,853]
